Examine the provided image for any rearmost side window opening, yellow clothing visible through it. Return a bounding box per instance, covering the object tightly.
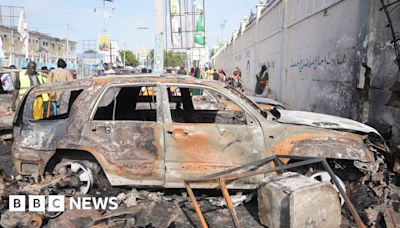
[32,89,82,121]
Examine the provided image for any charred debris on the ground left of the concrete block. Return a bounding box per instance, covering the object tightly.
[0,172,262,227]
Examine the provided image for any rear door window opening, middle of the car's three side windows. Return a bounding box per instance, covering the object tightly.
[94,86,157,122]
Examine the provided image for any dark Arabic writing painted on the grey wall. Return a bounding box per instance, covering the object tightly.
[290,53,347,72]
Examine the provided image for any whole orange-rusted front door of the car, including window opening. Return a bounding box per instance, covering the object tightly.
[159,85,264,188]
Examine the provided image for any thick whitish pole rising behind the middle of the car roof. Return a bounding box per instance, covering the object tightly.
[154,0,165,75]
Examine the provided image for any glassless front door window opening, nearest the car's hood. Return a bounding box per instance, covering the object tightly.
[168,87,247,124]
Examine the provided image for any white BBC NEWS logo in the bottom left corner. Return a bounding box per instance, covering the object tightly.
[8,195,118,212]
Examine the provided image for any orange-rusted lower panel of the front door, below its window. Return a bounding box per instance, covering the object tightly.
[165,123,265,187]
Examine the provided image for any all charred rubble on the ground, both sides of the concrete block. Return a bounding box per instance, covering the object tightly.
[0,141,400,228]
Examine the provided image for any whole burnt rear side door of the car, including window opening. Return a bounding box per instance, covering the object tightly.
[82,84,165,186]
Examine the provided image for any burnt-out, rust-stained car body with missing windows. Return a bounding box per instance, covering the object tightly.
[12,76,388,192]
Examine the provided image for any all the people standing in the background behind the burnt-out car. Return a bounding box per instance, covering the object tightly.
[1,59,269,115]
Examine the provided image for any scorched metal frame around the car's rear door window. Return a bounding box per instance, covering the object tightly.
[89,82,164,123]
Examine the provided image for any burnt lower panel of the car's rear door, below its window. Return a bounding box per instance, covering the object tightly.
[82,121,165,185]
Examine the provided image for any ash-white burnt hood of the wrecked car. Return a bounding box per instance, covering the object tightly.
[277,110,380,136]
